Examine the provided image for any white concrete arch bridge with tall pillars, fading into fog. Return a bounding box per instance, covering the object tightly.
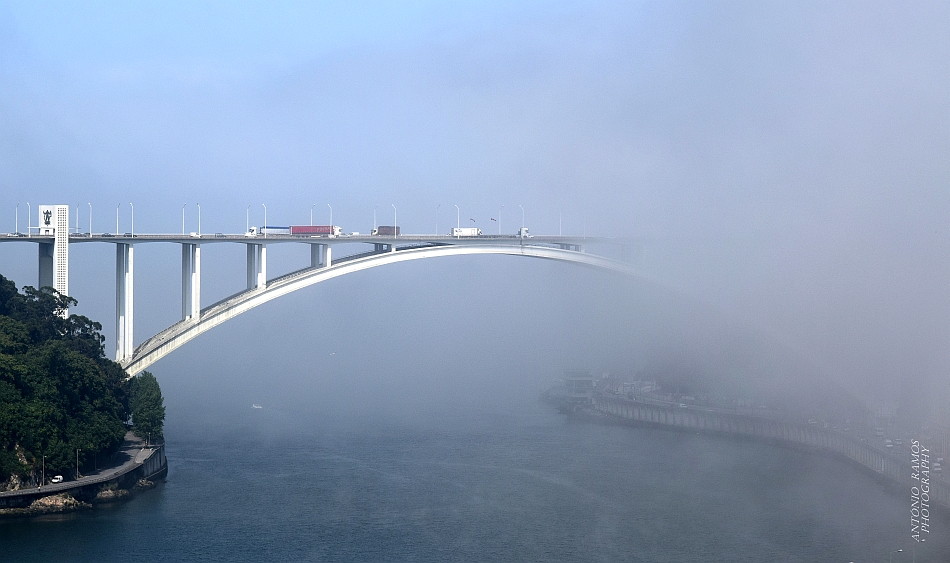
[0,206,635,375]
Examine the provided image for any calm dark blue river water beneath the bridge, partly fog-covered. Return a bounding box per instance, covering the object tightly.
[0,396,950,562]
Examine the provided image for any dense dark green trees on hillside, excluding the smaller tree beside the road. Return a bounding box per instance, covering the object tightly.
[0,275,129,481]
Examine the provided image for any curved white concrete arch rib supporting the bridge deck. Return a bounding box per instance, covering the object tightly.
[120,244,635,376]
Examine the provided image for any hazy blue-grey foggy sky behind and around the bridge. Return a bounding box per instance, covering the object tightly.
[0,1,950,418]
